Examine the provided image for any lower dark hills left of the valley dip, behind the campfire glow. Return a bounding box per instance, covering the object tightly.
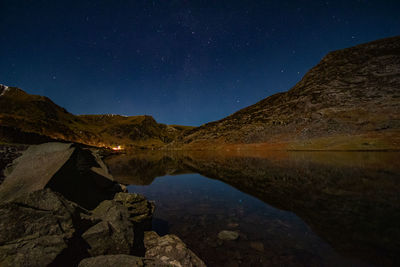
[0,85,190,148]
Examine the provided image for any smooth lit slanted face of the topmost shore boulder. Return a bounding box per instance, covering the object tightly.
[0,143,75,202]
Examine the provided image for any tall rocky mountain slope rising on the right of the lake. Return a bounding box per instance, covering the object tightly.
[169,36,400,150]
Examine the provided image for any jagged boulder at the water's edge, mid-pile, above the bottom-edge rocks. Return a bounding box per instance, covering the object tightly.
[82,192,154,256]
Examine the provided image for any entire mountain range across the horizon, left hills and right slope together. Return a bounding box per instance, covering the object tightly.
[0,36,400,150]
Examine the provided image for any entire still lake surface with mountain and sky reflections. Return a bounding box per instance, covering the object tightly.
[107,152,400,266]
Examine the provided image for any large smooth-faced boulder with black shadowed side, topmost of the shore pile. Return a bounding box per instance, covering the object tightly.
[0,142,122,209]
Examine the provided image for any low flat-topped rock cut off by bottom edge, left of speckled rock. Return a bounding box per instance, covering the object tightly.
[79,255,148,267]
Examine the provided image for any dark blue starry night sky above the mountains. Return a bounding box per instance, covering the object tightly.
[0,0,400,125]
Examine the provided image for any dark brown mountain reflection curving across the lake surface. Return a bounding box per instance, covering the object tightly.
[107,152,400,265]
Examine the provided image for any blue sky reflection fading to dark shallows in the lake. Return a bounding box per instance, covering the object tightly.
[128,174,368,266]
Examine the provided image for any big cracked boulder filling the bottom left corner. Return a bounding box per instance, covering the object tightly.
[0,189,92,266]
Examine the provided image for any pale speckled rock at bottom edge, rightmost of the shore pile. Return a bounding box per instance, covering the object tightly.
[144,231,206,267]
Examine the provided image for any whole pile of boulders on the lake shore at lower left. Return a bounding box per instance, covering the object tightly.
[0,143,205,266]
